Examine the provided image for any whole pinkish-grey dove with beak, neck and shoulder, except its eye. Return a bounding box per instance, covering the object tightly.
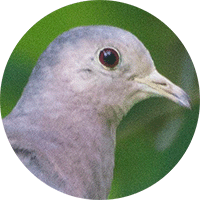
[3,26,190,199]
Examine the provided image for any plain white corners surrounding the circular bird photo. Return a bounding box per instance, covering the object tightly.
[0,0,200,200]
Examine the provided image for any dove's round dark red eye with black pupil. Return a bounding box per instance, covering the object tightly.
[99,48,119,69]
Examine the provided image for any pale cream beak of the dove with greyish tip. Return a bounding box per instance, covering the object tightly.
[134,70,191,108]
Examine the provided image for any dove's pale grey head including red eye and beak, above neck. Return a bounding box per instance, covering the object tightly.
[30,26,190,121]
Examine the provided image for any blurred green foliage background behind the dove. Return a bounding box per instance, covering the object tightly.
[1,1,199,198]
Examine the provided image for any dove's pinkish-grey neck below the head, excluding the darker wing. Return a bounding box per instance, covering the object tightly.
[8,85,116,199]
